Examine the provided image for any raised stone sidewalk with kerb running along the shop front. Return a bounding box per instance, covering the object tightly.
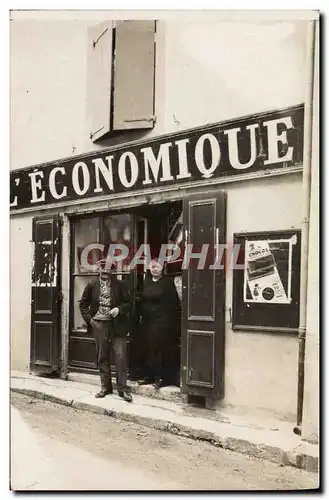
[11,372,319,472]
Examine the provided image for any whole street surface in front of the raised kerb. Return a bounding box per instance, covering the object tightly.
[11,393,317,491]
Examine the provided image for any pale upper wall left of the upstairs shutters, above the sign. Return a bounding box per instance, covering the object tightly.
[11,20,88,169]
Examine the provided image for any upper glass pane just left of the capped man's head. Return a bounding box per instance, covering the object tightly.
[74,217,103,273]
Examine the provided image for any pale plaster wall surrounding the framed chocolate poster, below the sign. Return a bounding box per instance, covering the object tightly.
[225,174,301,416]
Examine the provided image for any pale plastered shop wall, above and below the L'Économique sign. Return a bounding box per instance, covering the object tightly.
[11,12,306,413]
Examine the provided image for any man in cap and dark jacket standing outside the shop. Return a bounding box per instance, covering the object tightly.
[80,260,132,402]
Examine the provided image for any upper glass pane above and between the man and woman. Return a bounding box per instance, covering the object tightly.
[104,214,133,272]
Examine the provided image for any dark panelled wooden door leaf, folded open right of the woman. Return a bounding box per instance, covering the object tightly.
[181,191,226,398]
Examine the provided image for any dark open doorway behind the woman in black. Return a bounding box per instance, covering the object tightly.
[130,201,182,387]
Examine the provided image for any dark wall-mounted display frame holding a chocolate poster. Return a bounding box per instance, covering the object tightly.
[232,230,300,332]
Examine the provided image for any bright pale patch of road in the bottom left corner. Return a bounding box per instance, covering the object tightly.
[11,408,176,490]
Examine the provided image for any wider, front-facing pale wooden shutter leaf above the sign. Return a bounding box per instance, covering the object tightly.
[113,21,155,130]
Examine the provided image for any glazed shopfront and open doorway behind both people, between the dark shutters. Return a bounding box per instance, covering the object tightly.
[68,201,182,386]
